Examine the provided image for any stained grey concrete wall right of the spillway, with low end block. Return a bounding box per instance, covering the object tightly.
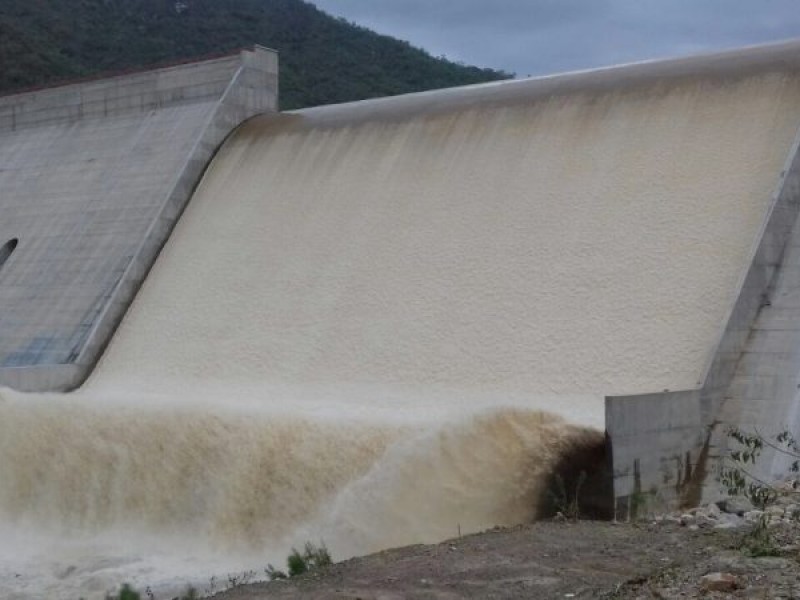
[606,88,800,510]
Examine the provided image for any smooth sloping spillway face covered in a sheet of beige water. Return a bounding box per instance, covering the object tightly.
[87,75,800,395]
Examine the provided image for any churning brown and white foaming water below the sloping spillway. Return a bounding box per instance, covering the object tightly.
[0,391,602,598]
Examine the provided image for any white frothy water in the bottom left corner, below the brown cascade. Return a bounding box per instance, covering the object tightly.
[0,525,276,600]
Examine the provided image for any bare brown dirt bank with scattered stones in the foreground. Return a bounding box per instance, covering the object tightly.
[215,521,800,600]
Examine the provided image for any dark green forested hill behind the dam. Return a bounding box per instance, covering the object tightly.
[0,0,510,109]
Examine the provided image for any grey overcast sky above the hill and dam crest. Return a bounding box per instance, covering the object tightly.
[311,0,800,77]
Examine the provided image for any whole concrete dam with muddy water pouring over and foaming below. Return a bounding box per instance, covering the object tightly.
[0,42,800,598]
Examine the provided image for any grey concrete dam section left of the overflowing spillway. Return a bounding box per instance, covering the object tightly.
[0,47,278,391]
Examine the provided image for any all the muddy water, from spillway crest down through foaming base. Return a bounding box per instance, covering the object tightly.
[0,64,800,598]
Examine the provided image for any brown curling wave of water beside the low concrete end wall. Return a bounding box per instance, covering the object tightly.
[300,408,602,556]
